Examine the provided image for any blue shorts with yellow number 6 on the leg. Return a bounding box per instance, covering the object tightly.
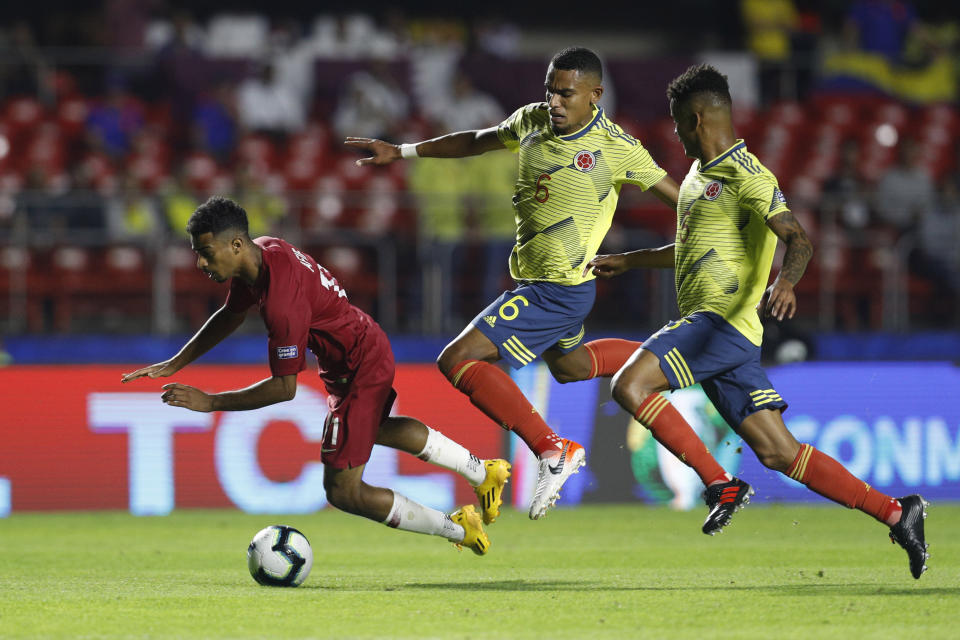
[471,280,597,369]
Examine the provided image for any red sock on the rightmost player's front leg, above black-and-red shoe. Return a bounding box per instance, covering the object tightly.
[633,393,730,487]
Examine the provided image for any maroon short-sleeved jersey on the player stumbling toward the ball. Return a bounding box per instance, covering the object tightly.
[226,236,386,383]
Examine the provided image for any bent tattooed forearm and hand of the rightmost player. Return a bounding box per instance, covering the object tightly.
[757,211,813,320]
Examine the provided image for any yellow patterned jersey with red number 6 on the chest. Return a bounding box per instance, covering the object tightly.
[498,102,667,285]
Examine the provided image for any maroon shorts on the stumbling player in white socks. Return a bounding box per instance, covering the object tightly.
[320,336,397,469]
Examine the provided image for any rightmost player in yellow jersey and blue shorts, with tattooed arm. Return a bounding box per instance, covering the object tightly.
[587,65,929,578]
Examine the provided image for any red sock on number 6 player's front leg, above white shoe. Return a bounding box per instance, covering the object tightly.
[448,360,560,456]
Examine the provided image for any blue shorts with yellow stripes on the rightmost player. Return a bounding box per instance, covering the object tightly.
[643,312,787,429]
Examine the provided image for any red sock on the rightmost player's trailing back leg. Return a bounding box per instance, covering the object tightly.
[787,444,902,526]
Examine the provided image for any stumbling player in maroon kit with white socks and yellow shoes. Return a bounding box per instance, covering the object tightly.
[123,197,510,555]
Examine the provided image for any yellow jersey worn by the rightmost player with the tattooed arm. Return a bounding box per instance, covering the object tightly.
[674,140,789,345]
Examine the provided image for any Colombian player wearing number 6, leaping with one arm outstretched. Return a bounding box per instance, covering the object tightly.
[346,47,677,520]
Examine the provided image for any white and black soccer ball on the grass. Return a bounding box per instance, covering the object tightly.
[247,524,313,587]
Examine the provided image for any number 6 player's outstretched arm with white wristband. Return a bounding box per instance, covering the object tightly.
[344,127,506,166]
